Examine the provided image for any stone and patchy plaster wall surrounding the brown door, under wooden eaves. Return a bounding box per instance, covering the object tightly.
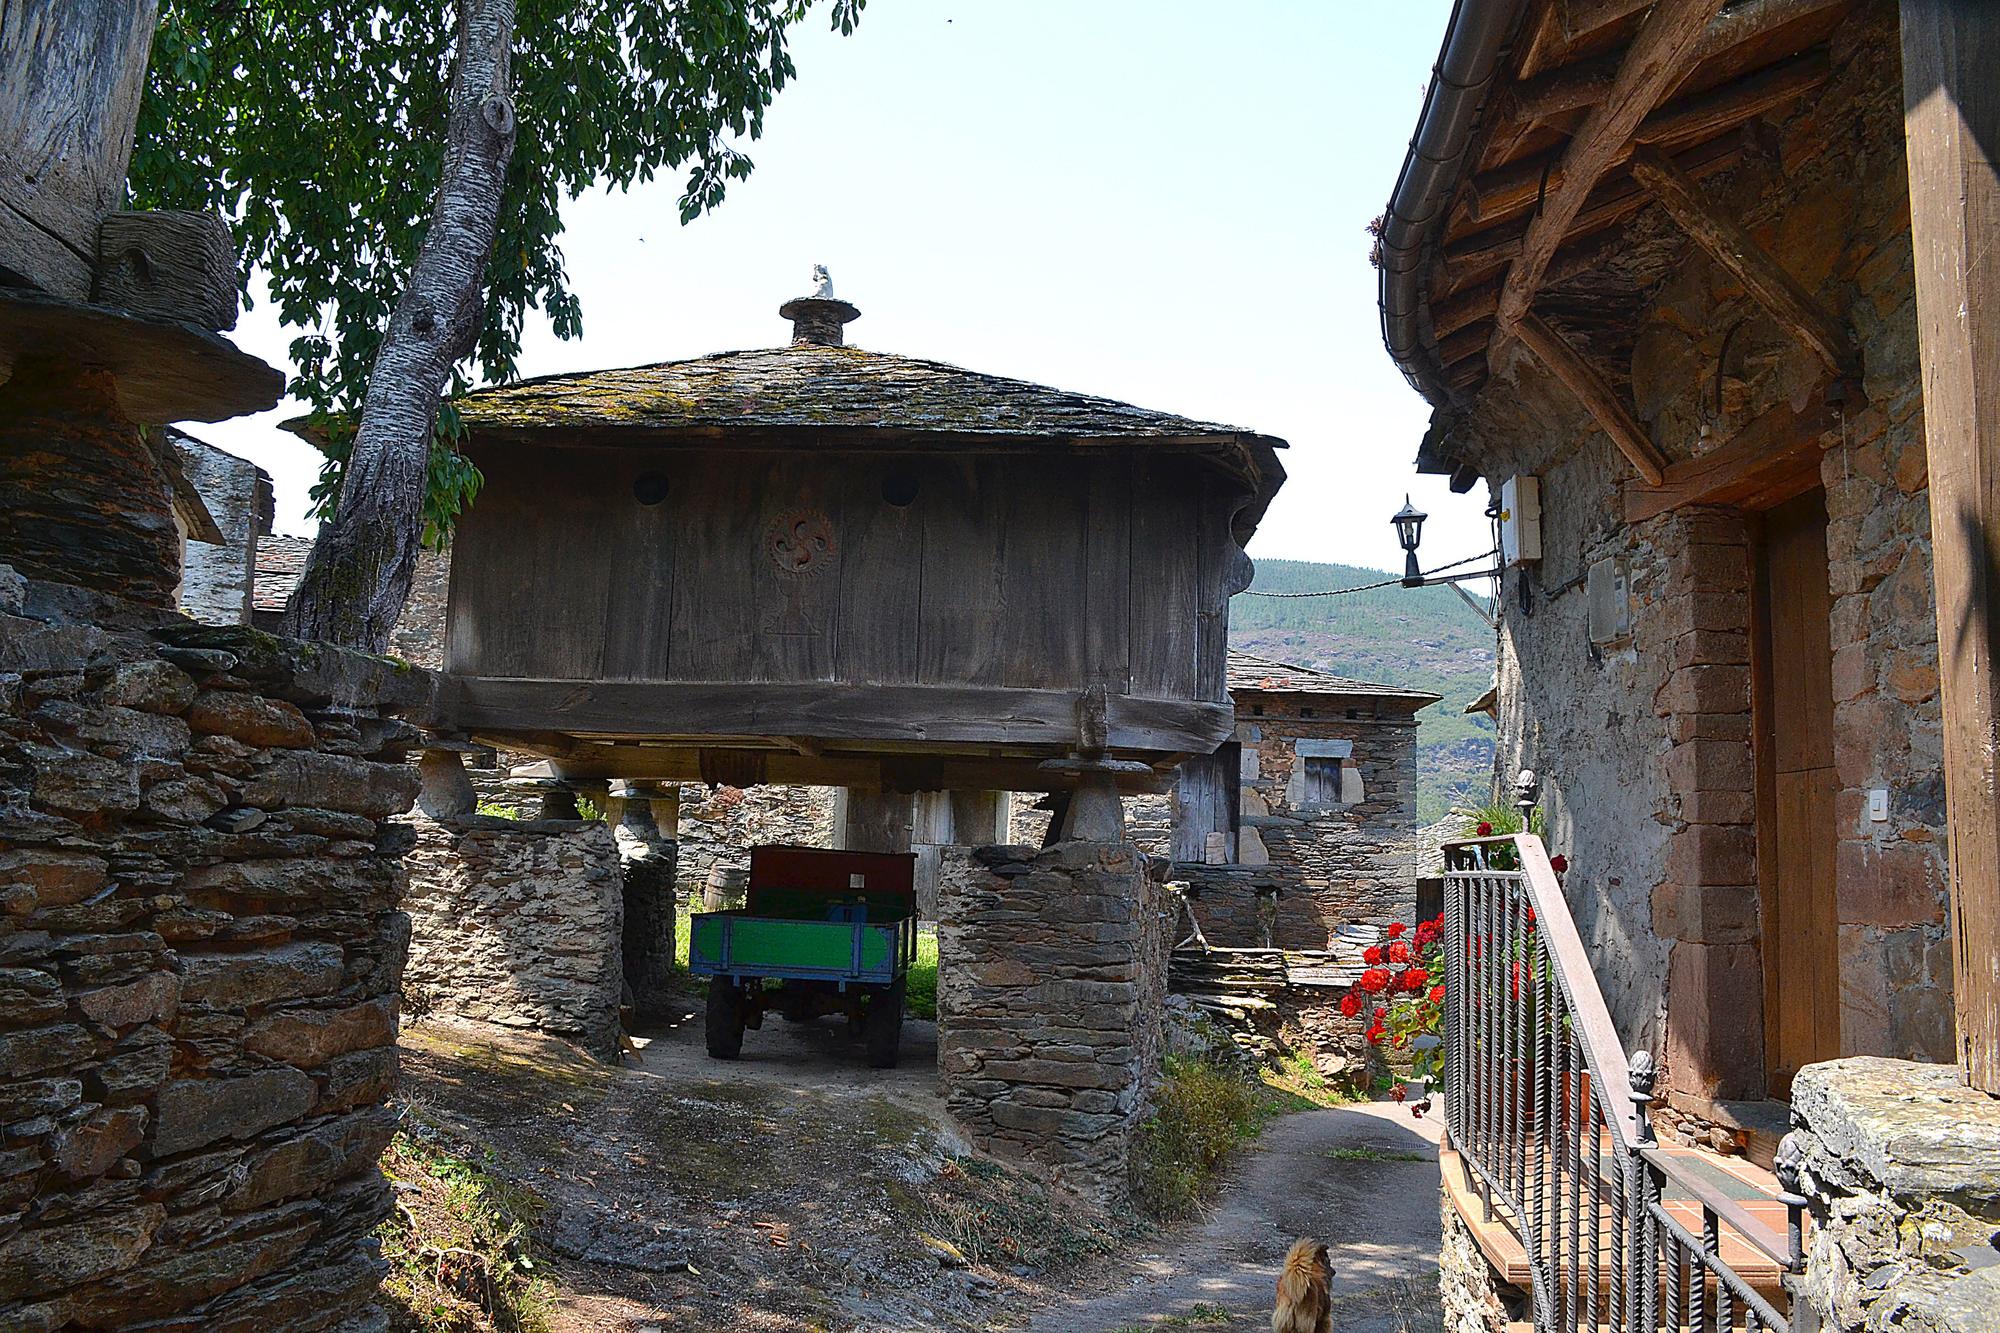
[1452,2,1952,1111]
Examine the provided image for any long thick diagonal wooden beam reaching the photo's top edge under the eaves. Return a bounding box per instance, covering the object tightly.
[1494,0,1722,342]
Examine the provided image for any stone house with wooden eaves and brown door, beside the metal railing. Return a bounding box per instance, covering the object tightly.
[1378,0,2000,1329]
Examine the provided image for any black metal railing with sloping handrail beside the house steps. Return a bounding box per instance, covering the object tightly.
[1444,835,1804,1333]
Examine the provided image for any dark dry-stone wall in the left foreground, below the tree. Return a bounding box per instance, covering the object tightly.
[0,588,430,1333]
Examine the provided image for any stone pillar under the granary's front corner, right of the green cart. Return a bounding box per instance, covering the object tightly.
[938,843,1170,1205]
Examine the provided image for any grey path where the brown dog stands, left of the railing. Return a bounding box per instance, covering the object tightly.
[1028,1103,1438,1333]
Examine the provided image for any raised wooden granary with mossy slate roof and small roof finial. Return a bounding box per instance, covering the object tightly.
[390,280,1284,791]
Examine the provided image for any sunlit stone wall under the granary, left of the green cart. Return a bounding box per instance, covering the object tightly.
[402,815,624,1059]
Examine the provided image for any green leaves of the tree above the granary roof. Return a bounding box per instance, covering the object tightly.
[132,0,864,538]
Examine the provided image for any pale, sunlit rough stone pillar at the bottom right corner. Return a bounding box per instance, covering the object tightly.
[1778,1057,2000,1333]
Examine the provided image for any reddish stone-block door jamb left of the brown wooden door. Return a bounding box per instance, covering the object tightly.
[1652,508,1764,1099]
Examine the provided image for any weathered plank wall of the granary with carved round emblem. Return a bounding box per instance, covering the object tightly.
[446,444,1248,701]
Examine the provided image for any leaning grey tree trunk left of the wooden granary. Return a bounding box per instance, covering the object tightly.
[284,0,514,652]
